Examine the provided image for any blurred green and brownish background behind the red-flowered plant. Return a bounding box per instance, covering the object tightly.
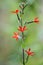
[0,0,43,65]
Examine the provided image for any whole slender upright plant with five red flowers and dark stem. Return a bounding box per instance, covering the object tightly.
[12,2,39,65]
